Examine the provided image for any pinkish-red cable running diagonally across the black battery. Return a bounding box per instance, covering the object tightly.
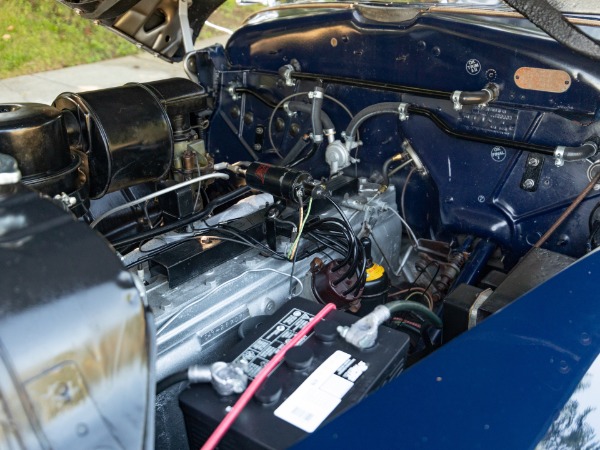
[201,303,336,450]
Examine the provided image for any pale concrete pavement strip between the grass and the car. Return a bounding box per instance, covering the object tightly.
[0,35,229,104]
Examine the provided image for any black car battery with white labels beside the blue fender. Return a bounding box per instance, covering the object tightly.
[179,299,409,449]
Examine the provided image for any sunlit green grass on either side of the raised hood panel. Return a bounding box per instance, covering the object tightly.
[0,0,263,79]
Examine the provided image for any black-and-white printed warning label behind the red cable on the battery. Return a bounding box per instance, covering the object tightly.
[235,308,314,379]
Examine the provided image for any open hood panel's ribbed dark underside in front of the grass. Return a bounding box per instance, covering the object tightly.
[58,0,225,62]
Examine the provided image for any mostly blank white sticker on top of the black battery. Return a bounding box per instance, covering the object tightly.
[274,350,368,433]
